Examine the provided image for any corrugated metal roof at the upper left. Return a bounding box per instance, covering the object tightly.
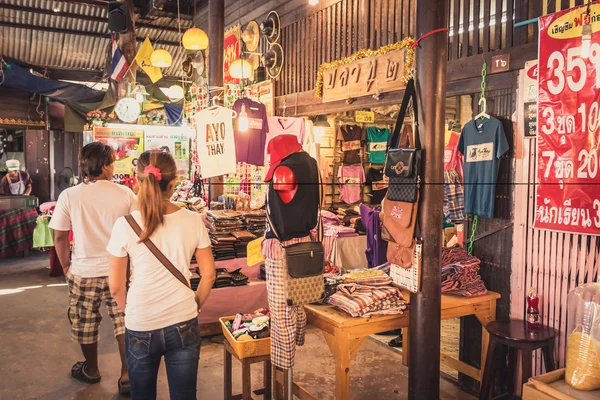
[0,0,191,77]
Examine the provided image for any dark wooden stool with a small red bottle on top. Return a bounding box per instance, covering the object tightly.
[479,320,556,400]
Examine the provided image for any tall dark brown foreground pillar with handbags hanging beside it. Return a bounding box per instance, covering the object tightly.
[408,0,449,400]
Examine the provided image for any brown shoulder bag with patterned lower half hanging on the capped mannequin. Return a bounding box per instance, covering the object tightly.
[267,178,325,306]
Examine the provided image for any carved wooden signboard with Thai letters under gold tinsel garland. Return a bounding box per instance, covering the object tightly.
[323,49,407,103]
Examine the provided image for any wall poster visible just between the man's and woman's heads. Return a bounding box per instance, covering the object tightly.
[94,127,144,185]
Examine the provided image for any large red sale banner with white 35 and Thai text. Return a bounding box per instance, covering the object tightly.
[534,4,600,235]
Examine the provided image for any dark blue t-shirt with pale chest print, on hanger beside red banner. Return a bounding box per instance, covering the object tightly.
[458,118,508,218]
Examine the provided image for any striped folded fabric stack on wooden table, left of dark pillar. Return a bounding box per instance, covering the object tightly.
[327,283,406,318]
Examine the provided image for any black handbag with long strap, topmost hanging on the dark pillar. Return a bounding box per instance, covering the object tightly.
[384,79,422,203]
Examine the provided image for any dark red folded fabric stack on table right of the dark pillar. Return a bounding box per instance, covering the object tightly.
[442,247,487,297]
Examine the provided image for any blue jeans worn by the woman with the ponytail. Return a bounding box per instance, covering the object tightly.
[125,318,202,400]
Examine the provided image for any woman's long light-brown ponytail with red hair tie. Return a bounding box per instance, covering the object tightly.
[137,151,177,243]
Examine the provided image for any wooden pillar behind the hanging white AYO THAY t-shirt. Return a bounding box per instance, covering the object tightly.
[208,0,225,201]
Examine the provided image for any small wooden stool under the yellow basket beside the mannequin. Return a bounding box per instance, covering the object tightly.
[223,340,271,400]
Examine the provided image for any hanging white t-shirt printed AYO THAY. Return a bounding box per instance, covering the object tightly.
[196,107,236,178]
